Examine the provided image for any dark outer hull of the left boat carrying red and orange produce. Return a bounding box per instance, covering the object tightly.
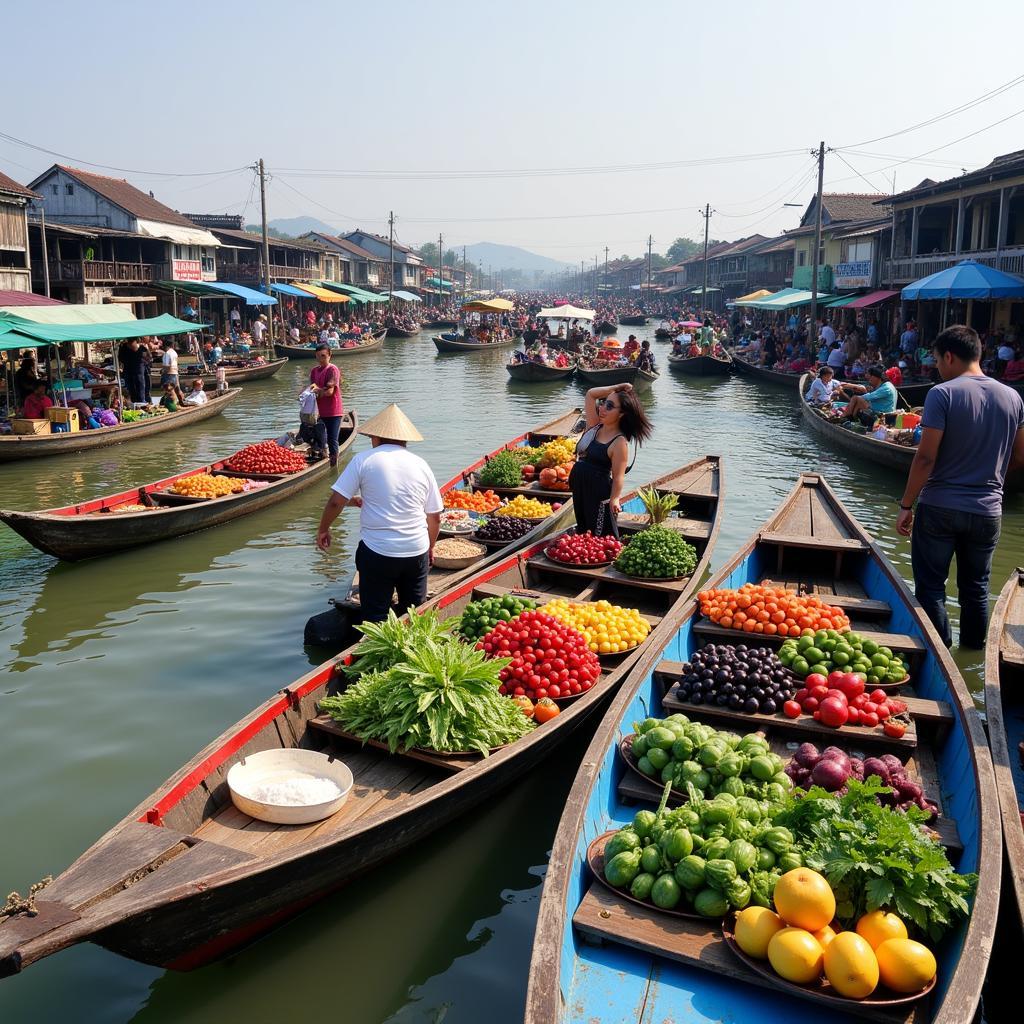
[0,413,358,562]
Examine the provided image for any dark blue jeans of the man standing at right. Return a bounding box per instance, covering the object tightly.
[910,504,1002,648]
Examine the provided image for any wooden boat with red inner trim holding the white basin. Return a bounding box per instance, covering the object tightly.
[0,459,721,977]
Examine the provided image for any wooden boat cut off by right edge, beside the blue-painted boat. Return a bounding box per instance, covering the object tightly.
[985,568,1024,937]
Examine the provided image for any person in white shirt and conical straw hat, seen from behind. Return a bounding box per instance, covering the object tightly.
[316,404,444,623]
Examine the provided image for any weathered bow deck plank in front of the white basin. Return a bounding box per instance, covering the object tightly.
[44,821,196,906]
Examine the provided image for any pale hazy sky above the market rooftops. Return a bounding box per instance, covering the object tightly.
[0,0,1024,263]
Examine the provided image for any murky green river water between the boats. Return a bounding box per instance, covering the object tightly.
[0,325,1024,1024]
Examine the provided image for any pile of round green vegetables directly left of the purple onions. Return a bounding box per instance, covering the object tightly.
[632,715,793,804]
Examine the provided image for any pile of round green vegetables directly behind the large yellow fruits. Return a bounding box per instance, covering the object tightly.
[604,783,803,919]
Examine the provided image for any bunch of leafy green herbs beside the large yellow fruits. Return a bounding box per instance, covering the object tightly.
[778,777,978,942]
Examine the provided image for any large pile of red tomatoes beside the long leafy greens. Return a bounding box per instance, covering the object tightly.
[476,610,601,700]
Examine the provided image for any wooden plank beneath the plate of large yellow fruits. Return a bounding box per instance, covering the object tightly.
[572,884,923,1022]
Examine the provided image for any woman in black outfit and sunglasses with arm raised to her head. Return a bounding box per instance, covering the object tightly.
[569,384,651,537]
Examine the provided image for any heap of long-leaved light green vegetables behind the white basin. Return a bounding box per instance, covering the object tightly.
[321,612,536,756]
